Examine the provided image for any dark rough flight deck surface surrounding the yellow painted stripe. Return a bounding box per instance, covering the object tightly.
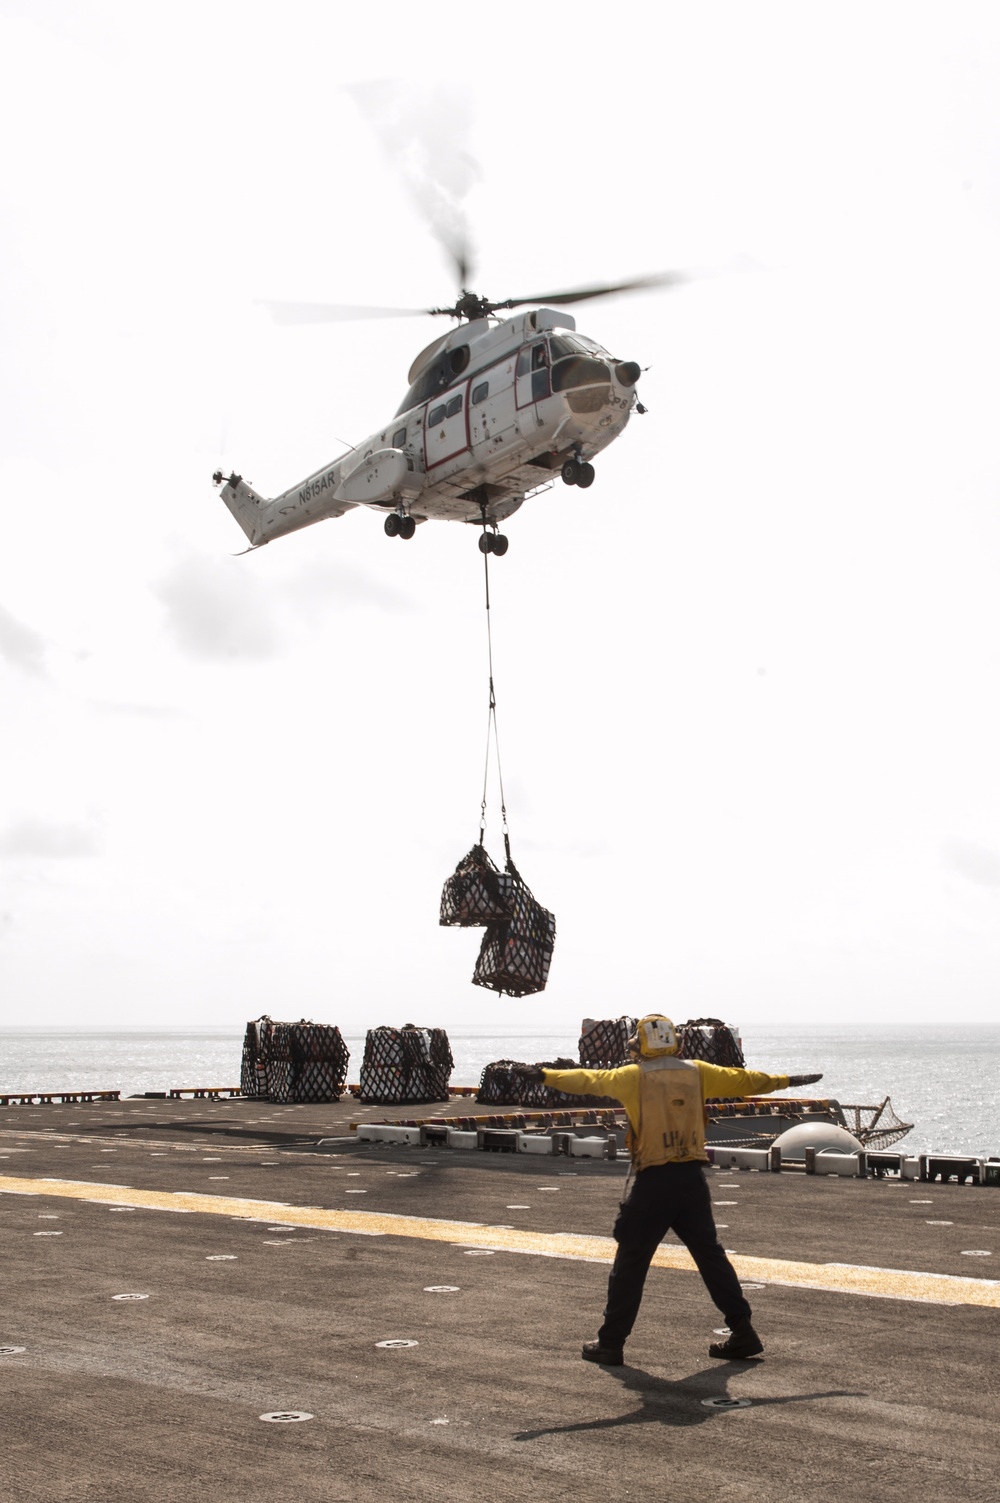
[0,1100,1000,1503]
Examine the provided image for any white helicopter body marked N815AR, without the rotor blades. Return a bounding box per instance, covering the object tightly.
[215,308,639,547]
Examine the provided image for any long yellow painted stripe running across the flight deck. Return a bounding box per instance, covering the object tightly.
[0,1175,1000,1309]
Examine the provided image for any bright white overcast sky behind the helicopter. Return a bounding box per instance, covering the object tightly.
[0,0,1000,1036]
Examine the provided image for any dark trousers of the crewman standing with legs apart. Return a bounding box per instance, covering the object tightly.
[597,1163,750,1347]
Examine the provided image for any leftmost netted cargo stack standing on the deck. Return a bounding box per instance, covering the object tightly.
[239,1016,350,1103]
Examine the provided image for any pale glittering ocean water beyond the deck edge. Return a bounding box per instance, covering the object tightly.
[0,1024,1000,1154]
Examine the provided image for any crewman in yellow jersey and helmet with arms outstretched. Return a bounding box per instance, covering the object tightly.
[514,1013,821,1366]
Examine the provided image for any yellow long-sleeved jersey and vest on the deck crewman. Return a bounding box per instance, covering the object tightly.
[544,1055,788,1169]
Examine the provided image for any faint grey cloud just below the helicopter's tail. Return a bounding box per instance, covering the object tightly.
[153,558,283,661]
